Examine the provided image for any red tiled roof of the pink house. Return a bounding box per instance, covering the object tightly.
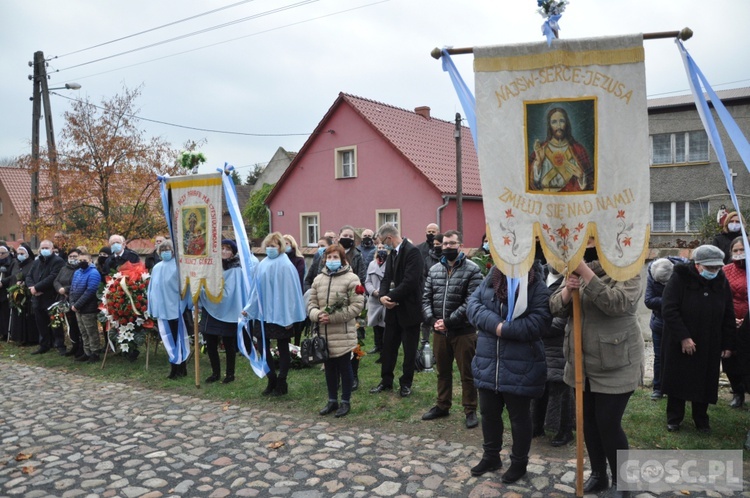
[342,93,482,196]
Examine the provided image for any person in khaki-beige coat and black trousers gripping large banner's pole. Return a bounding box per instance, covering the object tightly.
[550,239,644,493]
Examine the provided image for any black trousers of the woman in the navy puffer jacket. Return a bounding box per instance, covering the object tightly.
[479,389,531,461]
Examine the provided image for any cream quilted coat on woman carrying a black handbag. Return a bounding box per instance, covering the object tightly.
[307,265,365,358]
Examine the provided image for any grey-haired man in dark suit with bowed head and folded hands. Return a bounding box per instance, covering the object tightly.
[370,224,424,397]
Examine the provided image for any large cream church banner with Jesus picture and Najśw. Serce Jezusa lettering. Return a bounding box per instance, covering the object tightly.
[474,35,650,280]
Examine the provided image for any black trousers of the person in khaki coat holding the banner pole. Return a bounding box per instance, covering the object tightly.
[583,380,633,479]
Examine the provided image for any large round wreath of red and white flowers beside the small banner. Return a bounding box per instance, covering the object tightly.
[99,262,156,353]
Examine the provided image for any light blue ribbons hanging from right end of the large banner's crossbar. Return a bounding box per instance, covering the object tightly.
[677,40,750,316]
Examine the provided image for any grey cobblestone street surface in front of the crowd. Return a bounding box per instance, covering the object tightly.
[0,363,750,498]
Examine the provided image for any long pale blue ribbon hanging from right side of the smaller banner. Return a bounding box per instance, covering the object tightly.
[217,163,270,379]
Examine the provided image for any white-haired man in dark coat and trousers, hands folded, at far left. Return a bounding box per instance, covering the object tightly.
[26,240,65,354]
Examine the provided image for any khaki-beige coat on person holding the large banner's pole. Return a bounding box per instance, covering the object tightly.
[550,262,644,394]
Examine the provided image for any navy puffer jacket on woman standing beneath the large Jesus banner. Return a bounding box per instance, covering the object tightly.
[467,265,552,398]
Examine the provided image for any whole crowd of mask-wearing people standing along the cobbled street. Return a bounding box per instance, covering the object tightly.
[0,213,750,494]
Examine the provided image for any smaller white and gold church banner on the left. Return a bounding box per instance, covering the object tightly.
[165,173,224,303]
